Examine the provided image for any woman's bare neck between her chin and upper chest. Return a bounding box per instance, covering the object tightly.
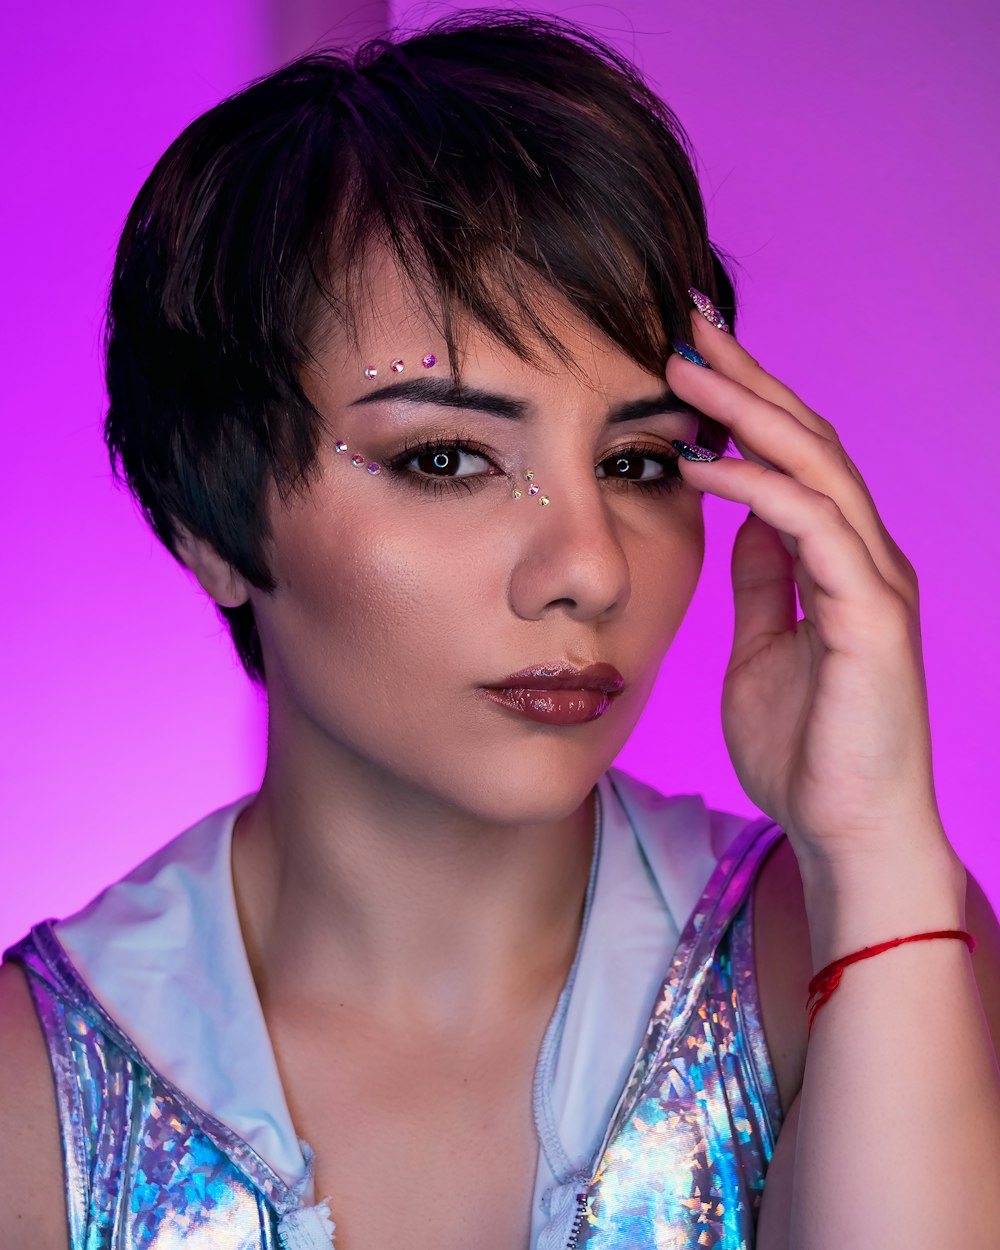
[233,720,596,1026]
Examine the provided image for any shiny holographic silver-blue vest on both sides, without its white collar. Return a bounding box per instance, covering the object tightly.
[5,821,783,1250]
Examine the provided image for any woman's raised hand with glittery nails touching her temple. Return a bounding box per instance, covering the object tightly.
[666,314,946,864]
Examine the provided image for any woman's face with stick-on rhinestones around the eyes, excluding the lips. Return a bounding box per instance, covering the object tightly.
[251,255,704,823]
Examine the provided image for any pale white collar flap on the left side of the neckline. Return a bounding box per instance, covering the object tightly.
[55,795,306,1186]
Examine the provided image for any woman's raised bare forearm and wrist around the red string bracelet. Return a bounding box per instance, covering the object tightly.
[790,838,1000,1250]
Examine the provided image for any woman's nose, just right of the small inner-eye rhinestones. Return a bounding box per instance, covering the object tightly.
[509,473,631,620]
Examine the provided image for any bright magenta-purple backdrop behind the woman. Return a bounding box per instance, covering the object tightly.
[0,0,1000,944]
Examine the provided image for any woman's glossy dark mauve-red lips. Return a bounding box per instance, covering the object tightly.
[483,664,625,725]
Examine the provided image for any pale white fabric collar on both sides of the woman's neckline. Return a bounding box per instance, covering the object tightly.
[56,769,744,1201]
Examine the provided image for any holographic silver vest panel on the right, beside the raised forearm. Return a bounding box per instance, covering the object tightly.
[570,825,781,1250]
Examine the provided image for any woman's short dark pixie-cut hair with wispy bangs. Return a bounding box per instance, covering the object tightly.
[105,11,735,684]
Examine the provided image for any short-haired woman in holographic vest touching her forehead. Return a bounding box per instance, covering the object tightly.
[0,15,1000,1250]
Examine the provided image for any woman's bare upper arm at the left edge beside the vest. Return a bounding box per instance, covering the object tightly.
[0,963,68,1250]
